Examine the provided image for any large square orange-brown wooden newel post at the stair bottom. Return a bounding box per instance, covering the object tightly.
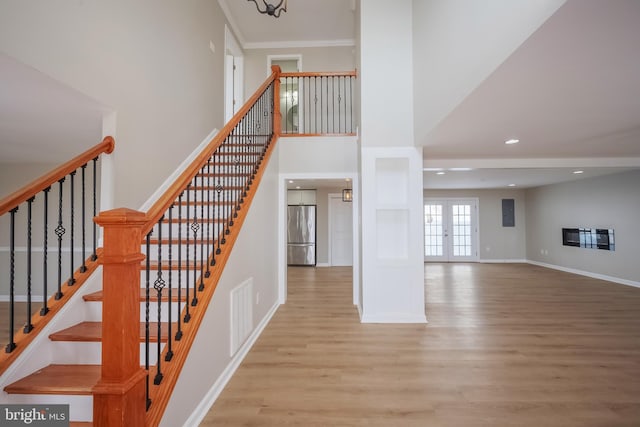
[93,209,147,427]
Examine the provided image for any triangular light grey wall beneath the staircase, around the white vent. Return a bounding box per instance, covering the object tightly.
[161,147,278,427]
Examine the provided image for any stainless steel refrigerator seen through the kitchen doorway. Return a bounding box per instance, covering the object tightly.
[287,205,316,266]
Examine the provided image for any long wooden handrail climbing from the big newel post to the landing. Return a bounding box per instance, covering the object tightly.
[142,66,282,235]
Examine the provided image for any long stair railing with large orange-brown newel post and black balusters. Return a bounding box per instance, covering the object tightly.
[93,66,280,427]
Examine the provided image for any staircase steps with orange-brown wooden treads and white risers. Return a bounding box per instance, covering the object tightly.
[4,181,234,425]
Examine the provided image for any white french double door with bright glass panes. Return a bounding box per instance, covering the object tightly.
[424,199,478,262]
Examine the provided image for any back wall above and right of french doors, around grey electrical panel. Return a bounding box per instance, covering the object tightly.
[424,189,527,262]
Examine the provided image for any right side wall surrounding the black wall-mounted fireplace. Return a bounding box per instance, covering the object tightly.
[526,171,640,283]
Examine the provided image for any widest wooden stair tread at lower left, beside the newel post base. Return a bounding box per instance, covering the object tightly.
[4,365,101,395]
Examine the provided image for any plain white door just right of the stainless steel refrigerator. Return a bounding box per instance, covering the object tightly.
[329,194,353,266]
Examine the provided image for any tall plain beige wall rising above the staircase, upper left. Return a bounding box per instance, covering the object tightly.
[0,0,225,208]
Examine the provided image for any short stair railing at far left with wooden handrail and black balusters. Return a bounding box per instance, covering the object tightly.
[0,136,115,373]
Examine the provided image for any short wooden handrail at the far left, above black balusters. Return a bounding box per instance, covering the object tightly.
[0,136,115,216]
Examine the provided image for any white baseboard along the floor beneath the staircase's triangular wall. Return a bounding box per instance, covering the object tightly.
[184,303,280,427]
